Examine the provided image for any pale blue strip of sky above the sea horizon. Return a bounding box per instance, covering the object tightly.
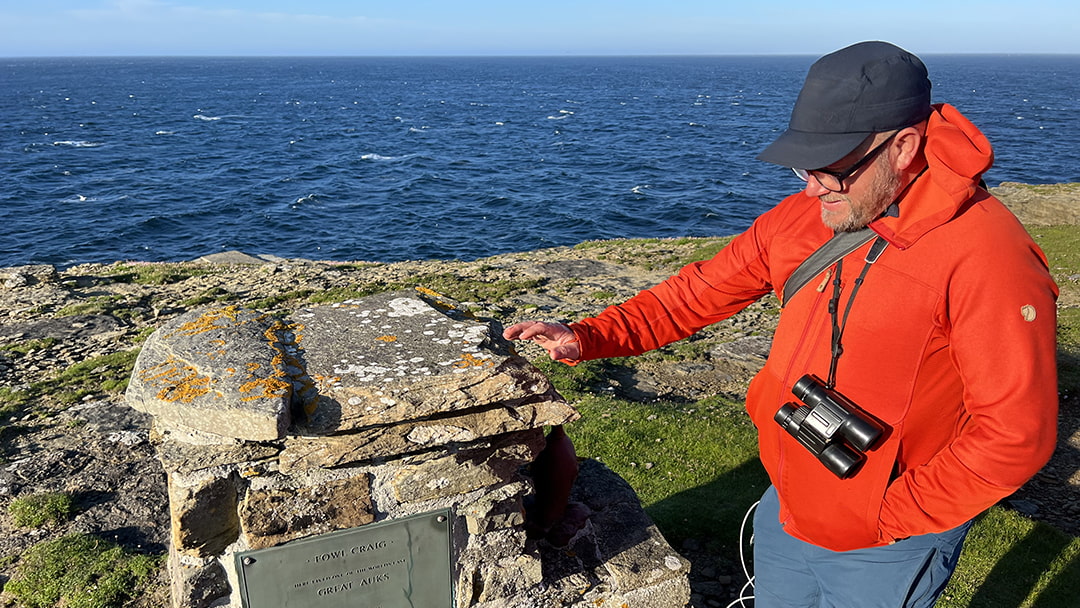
[0,0,1080,57]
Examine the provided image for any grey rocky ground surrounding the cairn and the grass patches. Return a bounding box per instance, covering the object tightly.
[0,185,1080,606]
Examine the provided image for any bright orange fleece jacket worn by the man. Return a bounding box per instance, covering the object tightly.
[571,105,1057,551]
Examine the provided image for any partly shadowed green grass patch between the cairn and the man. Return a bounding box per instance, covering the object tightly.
[583,396,768,555]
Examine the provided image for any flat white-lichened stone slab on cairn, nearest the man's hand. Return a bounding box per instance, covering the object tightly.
[293,292,562,434]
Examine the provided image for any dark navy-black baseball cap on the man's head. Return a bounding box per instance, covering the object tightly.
[757,41,930,168]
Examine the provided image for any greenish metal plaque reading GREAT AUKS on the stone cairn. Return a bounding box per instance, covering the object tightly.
[235,510,454,608]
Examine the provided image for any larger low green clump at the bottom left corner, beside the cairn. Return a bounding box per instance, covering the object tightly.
[4,533,162,608]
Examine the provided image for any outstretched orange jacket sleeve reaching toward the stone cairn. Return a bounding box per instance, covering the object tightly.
[570,218,772,360]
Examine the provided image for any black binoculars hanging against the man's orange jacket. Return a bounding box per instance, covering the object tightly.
[773,374,883,479]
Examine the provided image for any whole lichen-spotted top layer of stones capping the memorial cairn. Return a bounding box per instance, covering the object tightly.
[127,289,577,443]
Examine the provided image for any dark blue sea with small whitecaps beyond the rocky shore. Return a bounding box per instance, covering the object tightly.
[0,55,1080,268]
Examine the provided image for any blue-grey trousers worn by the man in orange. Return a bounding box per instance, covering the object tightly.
[754,486,971,608]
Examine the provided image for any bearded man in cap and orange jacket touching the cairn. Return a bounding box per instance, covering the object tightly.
[504,42,1057,608]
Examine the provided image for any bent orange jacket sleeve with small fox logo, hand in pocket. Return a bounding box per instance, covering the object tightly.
[879,231,1057,541]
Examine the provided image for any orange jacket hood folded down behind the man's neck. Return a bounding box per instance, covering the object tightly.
[870,104,994,249]
